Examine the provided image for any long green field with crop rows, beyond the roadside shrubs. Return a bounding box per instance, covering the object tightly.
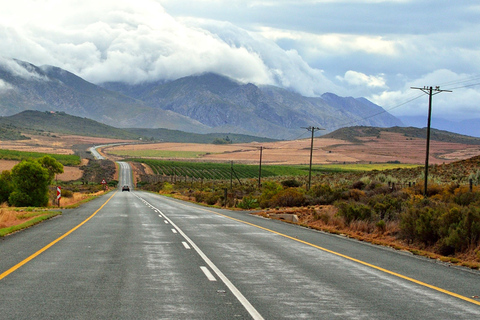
[127,159,416,180]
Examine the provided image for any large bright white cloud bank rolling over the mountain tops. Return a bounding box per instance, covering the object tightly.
[0,0,335,91]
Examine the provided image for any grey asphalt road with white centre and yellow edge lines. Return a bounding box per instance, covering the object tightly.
[0,164,480,319]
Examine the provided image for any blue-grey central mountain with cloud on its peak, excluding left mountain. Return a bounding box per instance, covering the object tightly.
[105,73,402,139]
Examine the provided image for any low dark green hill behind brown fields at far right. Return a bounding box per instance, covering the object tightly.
[321,126,480,145]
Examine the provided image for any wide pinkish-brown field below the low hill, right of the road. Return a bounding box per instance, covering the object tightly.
[104,132,480,165]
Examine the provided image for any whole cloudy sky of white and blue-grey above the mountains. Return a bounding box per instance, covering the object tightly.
[0,0,480,120]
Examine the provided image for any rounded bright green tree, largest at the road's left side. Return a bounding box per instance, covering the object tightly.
[8,161,50,207]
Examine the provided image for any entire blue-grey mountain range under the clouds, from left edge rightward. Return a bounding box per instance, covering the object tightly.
[0,60,402,139]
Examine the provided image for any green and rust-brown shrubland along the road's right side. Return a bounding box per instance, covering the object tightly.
[139,158,480,268]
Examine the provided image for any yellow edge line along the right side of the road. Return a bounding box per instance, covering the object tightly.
[179,204,480,306]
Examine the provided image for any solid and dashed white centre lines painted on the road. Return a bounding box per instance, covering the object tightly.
[134,194,264,320]
